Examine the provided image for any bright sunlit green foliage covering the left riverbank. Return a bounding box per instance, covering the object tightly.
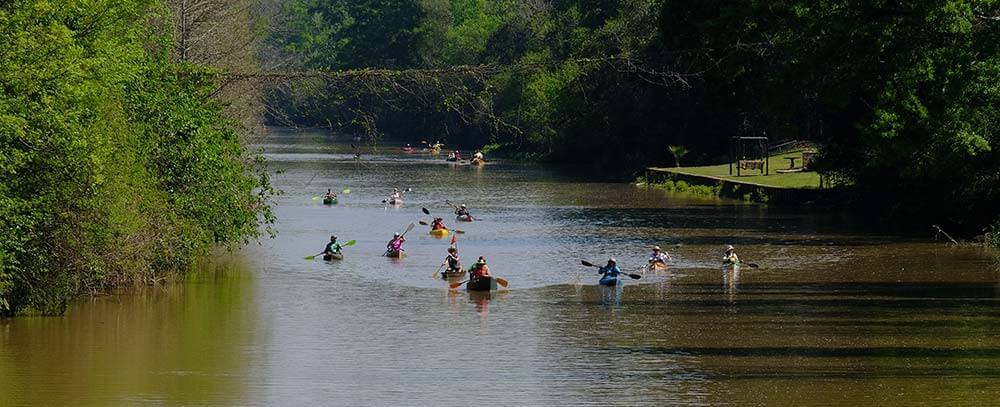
[0,0,271,315]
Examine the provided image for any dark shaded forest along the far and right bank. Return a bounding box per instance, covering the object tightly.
[270,0,1000,236]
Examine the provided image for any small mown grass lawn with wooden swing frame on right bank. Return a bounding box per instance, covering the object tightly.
[655,151,819,188]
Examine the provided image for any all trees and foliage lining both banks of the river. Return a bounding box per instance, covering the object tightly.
[0,0,1000,316]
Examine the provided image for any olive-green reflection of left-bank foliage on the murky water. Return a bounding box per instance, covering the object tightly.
[0,263,258,406]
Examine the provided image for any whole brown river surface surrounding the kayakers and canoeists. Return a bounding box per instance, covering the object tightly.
[0,132,1000,405]
